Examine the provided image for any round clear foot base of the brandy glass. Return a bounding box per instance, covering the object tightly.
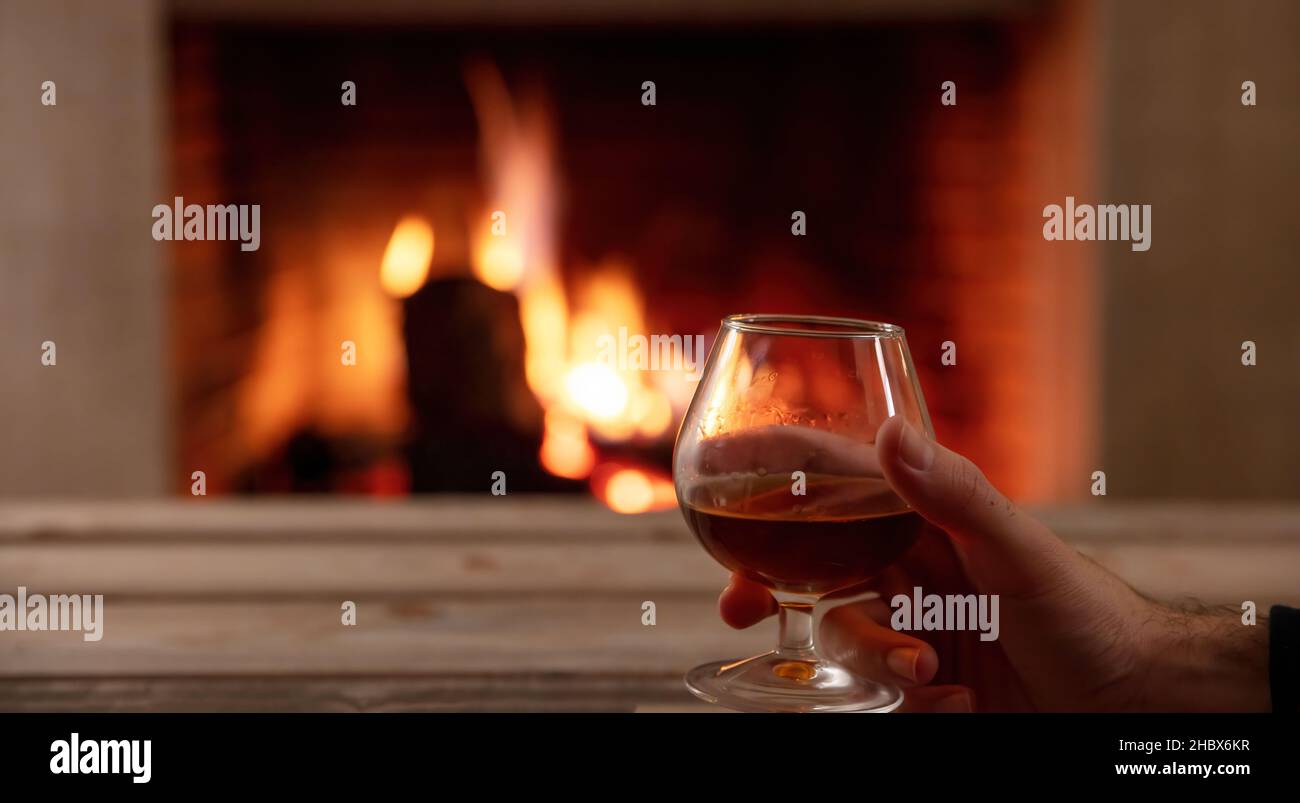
[686,652,902,713]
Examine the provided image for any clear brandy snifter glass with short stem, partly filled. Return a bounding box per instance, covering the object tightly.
[673,314,933,711]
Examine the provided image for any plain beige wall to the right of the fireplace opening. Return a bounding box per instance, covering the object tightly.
[1097,0,1300,499]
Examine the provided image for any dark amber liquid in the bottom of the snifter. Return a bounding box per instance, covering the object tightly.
[683,476,922,595]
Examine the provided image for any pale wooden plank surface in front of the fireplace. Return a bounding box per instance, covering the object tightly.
[0,496,1300,711]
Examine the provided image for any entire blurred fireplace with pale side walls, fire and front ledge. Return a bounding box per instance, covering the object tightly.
[10,0,1300,711]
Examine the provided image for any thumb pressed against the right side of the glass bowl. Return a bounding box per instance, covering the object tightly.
[876,416,1079,596]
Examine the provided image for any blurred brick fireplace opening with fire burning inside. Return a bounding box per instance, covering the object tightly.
[170,6,1095,512]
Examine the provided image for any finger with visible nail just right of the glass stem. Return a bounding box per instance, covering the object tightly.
[819,604,939,687]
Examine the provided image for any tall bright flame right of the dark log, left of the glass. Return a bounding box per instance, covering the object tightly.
[467,65,689,513]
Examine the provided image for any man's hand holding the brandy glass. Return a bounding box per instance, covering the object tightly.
[720,417,1269,711]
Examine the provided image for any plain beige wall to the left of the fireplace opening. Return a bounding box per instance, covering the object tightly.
[0,0,172,496]
